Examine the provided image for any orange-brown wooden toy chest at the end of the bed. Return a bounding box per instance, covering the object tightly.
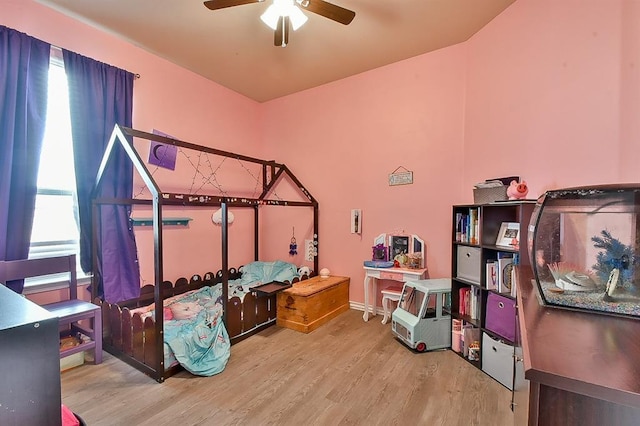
[276,276,349,333]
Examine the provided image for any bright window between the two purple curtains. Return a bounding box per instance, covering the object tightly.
[26,48,79,266]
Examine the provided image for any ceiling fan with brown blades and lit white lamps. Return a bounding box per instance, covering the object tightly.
[204,0,356,47]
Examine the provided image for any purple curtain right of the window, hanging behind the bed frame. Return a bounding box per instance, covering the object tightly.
[62,49,140,303]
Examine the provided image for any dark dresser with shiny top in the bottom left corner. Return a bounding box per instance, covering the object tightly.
[0,284,62,426]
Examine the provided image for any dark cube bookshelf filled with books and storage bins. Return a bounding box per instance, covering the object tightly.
[451,200,535,389]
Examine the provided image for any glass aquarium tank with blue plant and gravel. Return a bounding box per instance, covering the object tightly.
[528,184,640,318]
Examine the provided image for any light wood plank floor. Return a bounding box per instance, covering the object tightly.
[62,310,513,426]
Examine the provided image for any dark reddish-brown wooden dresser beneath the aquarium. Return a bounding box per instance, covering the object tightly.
[514,268,640,426]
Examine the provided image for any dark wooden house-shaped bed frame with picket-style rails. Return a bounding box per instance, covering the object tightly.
[92,125,318,382]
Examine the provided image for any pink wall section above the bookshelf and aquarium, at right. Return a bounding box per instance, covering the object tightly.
[464,0,640,196]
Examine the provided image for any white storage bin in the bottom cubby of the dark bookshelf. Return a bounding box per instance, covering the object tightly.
[482,333,524,390]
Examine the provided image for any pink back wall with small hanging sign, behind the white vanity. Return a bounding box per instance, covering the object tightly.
[261,45,466,302]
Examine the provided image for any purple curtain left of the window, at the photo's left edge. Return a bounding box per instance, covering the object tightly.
[0,26,51,293]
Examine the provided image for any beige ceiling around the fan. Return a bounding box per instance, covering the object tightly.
[38,0,515,102]
